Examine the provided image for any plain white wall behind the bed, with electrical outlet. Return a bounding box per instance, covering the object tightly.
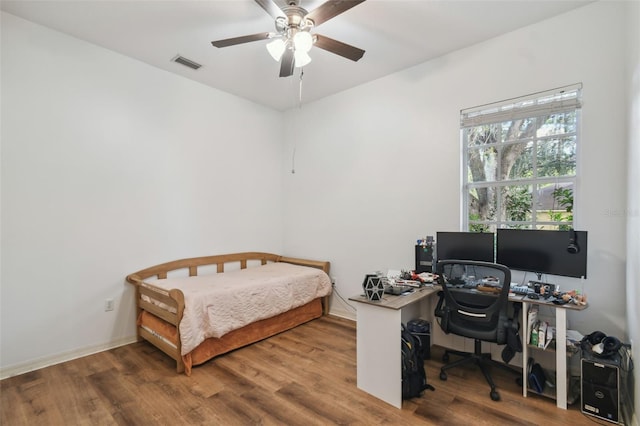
[0,13,283,377]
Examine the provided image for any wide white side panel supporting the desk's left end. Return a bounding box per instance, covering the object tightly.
[357,303,402,408]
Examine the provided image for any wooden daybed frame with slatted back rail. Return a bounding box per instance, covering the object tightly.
[127,252,330,375]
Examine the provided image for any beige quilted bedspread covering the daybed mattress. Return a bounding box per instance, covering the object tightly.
[148,262,331,355]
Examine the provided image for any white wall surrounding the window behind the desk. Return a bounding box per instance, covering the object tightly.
[284,2,637,339]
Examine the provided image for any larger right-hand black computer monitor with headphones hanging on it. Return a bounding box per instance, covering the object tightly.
[496,229,587,278]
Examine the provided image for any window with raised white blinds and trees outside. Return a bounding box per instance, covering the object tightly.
[460,85,582,232]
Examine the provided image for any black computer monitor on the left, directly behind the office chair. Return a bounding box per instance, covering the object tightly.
[436,232,495,262]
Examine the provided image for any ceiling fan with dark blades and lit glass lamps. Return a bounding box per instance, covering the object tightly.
[211,0,365,77]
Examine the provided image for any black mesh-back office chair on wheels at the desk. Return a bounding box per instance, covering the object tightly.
[435,260,517,401]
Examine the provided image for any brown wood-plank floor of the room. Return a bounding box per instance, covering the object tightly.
[0,316,598,426]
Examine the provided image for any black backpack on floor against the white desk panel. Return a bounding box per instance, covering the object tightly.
[401,324,435,399]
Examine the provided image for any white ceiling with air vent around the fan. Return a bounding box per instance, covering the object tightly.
[1,0,592,110]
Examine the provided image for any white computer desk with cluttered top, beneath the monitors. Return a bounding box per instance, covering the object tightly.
[349,285,586,410]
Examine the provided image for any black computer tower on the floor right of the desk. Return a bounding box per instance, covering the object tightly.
[581,354,624,424]
